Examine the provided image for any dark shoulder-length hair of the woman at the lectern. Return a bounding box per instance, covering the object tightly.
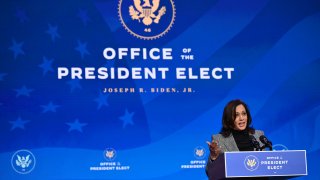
[220,99,255,137]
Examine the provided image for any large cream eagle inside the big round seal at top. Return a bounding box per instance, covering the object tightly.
[129,0,166,28]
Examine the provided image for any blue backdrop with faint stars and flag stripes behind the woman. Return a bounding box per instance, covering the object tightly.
[0,0,320,179]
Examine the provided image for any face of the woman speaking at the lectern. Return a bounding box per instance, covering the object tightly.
[234,104,248,131]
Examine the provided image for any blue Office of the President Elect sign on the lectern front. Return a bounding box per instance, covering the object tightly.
[224,150,308,178]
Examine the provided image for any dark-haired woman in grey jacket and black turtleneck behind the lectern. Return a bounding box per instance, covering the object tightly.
[206,100,263,178]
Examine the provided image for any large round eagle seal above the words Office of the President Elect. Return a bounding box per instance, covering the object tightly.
[118,0,176,40]
